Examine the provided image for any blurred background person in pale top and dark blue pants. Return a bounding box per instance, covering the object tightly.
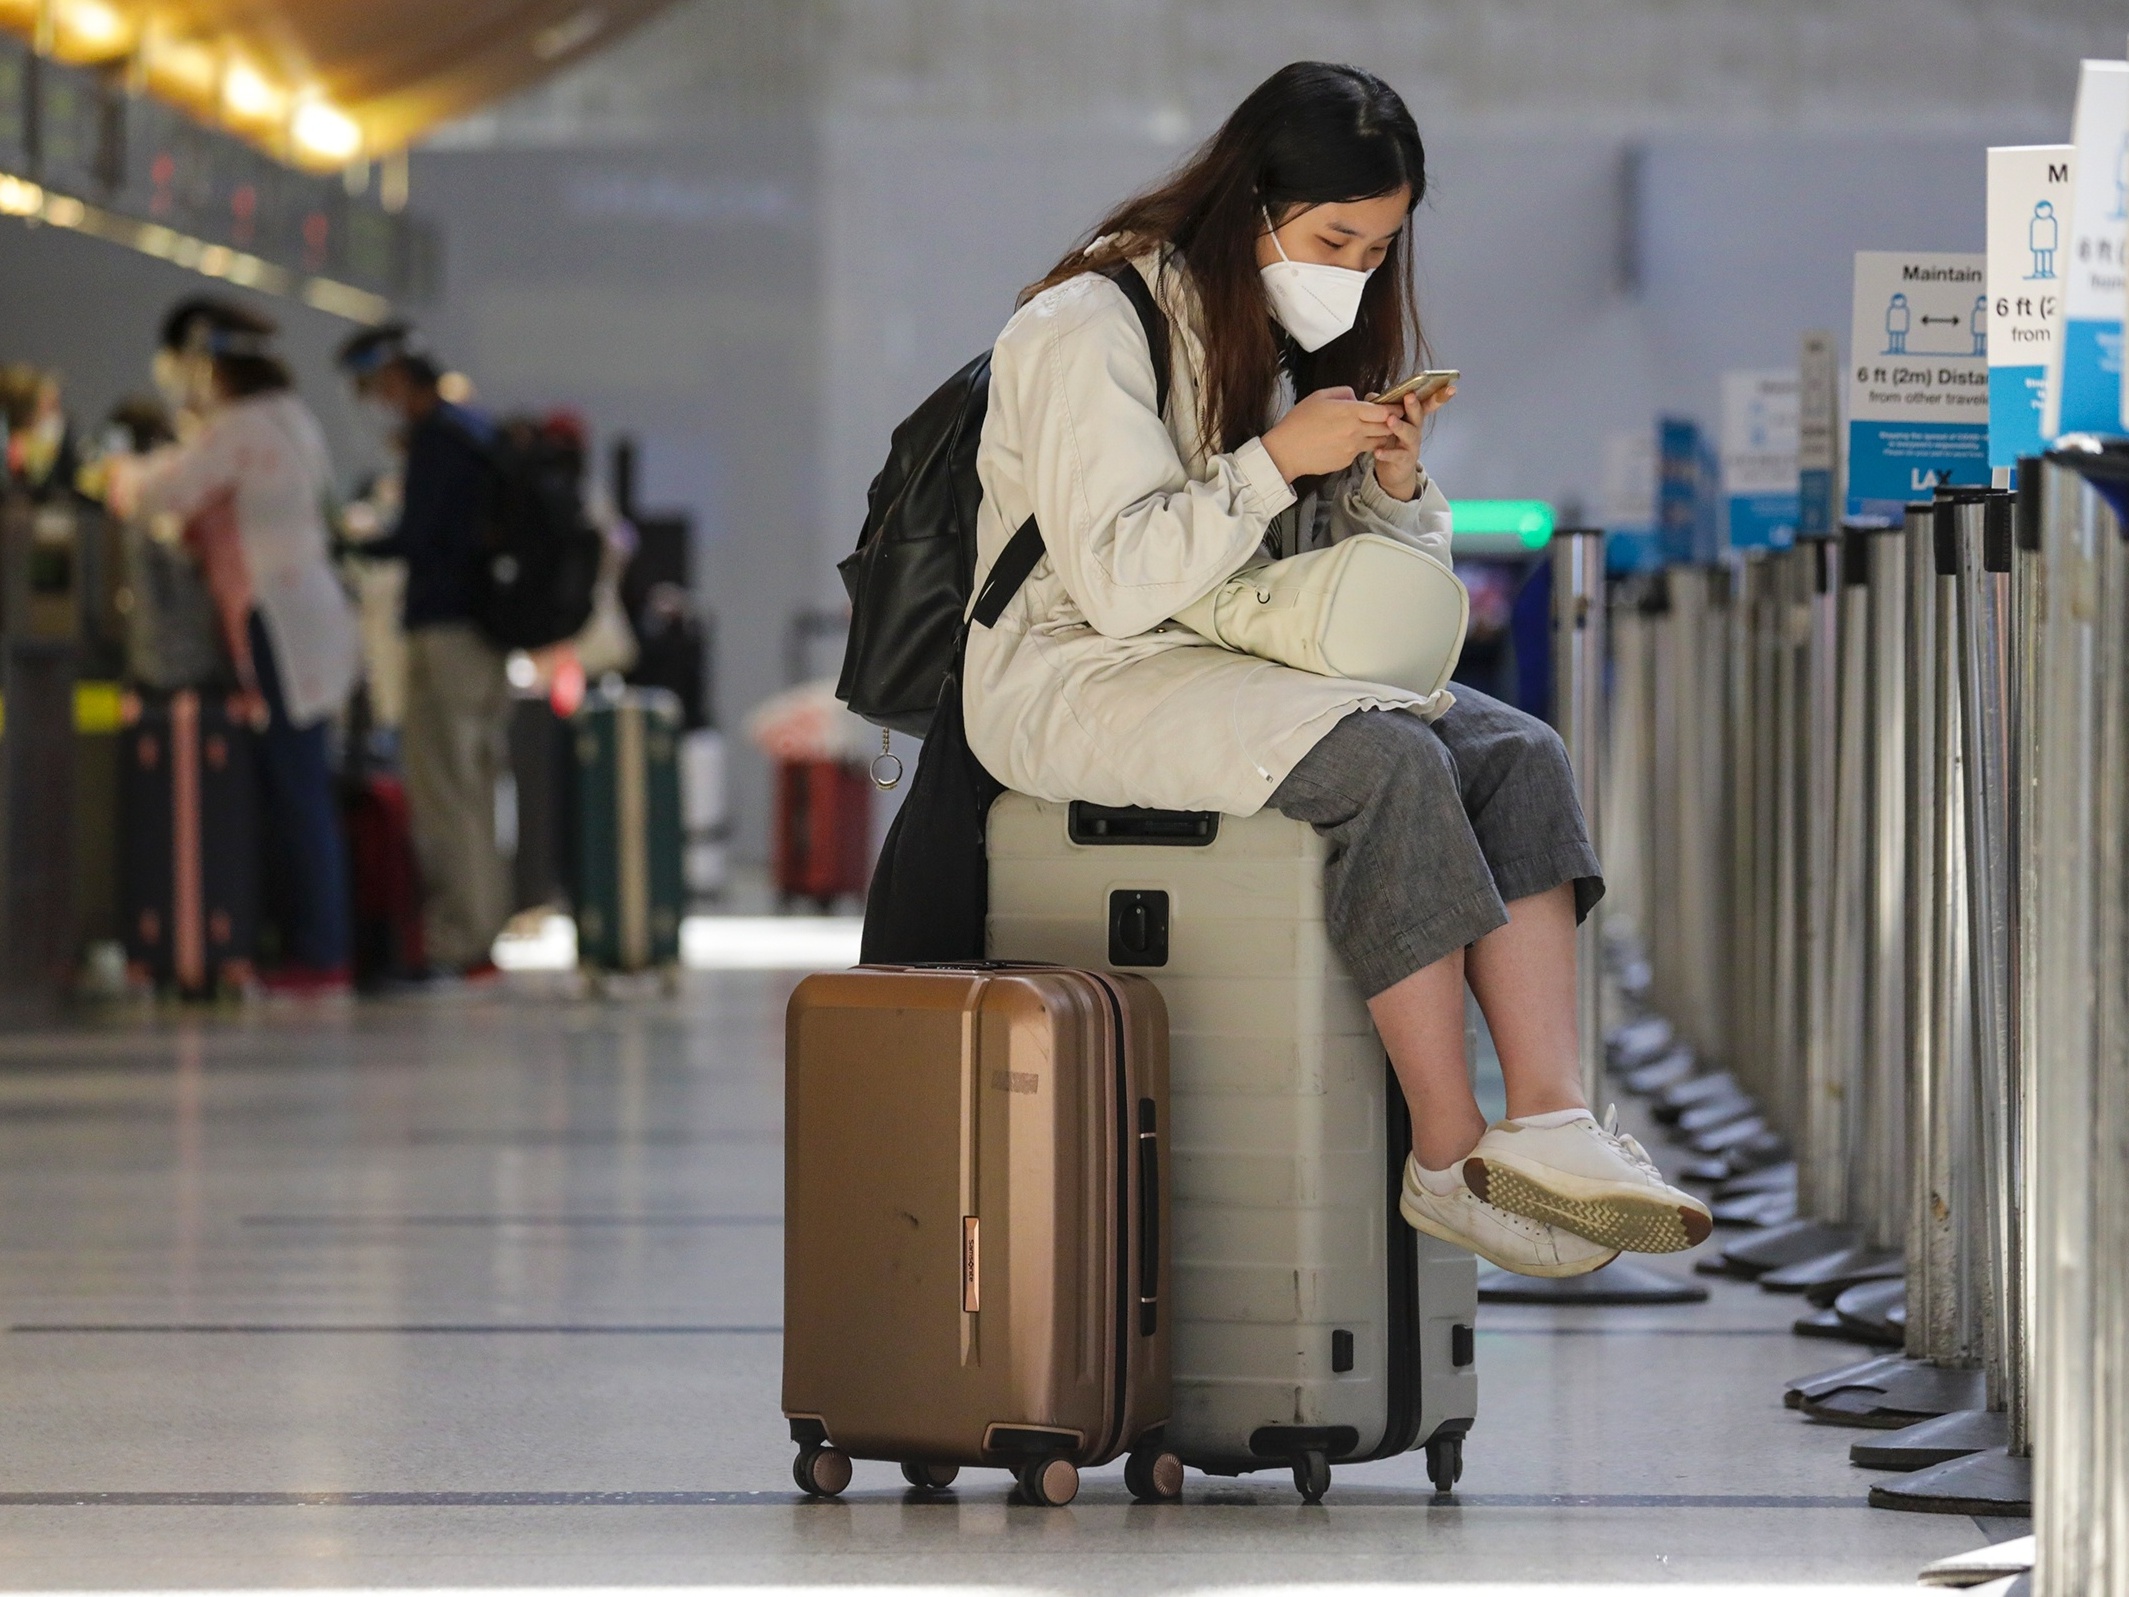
[109,296,358,992]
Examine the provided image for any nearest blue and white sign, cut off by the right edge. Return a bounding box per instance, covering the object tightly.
[2042,62,2129,441]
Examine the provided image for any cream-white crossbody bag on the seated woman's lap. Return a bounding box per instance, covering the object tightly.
[1175,532,1471,696]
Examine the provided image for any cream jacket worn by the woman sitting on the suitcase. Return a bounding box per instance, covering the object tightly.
[962,256,1450,816]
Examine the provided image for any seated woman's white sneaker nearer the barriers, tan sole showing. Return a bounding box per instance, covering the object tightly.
[1463,1105,1716,1254]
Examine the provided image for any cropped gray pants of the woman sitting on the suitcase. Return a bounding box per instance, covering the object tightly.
[1271,684,1603,997]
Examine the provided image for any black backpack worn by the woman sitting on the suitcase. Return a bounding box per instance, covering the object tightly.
[835,262,1169,737]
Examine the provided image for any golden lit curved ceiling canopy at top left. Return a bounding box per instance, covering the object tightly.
[0,0,673,168]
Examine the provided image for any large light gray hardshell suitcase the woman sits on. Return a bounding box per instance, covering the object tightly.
[988,794,1478,1501]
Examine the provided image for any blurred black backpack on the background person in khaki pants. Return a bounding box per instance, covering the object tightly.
[473,428,605,649]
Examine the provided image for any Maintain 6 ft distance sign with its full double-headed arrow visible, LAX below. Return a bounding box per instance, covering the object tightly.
[1848,249,1988,515]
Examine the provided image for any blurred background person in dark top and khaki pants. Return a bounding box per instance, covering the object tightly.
[339,324,511,977]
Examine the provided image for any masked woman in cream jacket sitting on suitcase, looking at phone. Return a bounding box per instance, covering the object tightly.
[964,62,1710,1275]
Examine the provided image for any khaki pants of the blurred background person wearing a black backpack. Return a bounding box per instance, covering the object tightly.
[400,622,511,971]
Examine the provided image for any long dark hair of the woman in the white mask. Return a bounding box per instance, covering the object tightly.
[1022,62,1426,451]
